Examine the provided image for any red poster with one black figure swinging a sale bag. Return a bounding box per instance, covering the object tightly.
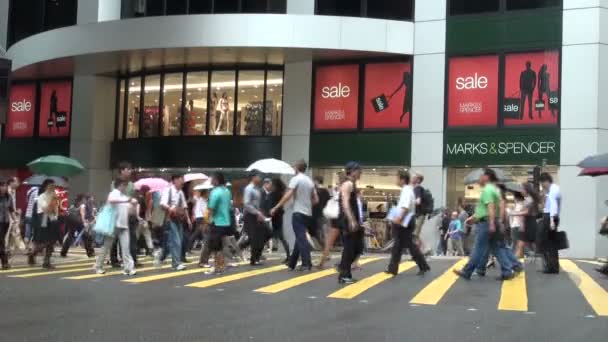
[363,63,413,129]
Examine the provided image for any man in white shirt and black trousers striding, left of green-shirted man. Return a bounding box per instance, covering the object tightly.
[386,170,431,275]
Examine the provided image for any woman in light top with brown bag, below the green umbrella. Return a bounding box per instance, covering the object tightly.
[28,179,60,269]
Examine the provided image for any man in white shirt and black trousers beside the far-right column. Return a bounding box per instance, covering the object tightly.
[540,172,562,274]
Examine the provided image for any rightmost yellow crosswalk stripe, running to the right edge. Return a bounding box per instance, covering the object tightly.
[560,260,608,316]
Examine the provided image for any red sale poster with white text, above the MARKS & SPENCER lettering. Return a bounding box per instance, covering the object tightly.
[446,56,498,127]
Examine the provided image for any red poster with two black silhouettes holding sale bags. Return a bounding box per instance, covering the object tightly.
[501,50,560,126]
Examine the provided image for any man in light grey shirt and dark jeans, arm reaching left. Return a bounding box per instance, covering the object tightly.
[270,160,319,271]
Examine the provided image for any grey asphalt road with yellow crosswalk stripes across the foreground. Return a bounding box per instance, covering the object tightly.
[0,254,608,342]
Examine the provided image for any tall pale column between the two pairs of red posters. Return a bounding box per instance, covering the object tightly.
[411,0,446,207]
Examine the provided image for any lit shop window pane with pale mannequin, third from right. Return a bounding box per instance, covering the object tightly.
[209,71,236,135]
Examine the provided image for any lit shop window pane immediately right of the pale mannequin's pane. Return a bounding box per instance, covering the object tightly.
[236,71,264,135]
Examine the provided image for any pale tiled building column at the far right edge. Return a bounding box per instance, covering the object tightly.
[559,0,608,258]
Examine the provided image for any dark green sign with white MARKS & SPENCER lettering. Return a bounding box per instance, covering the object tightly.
[444,134,560,165]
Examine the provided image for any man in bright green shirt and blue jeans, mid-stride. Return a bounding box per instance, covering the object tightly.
[454,168,514,280]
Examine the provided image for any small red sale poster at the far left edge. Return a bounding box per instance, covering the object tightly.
[5,84,36,138]
